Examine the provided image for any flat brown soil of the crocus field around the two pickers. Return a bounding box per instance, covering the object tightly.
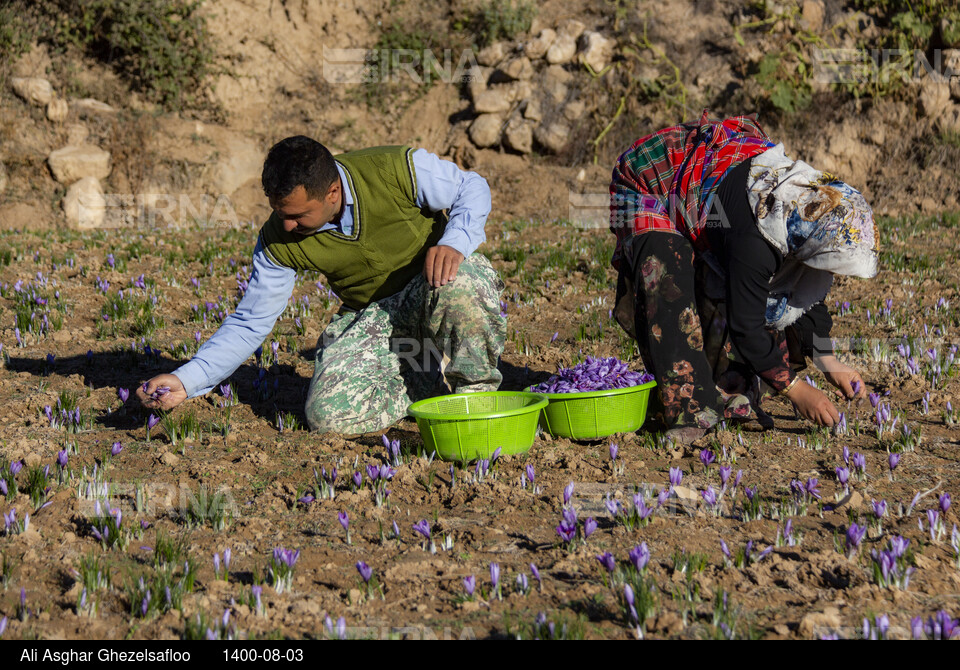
[0,209,960,638]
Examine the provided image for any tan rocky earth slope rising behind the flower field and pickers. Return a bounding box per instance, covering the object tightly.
[0,0,960,234]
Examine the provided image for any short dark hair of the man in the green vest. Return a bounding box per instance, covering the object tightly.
[260,135,339,200]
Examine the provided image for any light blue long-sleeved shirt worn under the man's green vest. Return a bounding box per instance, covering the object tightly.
[173,149,491,398]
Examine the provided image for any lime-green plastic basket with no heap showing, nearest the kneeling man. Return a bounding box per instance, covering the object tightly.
[408,391,547,462]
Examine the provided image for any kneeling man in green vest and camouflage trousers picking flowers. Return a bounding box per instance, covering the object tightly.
[137,136,506,434]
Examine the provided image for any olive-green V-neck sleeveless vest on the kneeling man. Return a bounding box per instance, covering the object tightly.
[260,147,447,309]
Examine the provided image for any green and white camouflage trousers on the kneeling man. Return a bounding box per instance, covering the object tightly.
[306,253,507,434]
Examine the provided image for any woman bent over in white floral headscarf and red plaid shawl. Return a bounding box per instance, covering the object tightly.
[610,112,877,443]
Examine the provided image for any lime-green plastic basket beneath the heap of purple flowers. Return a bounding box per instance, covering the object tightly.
[543,381,657,440]
